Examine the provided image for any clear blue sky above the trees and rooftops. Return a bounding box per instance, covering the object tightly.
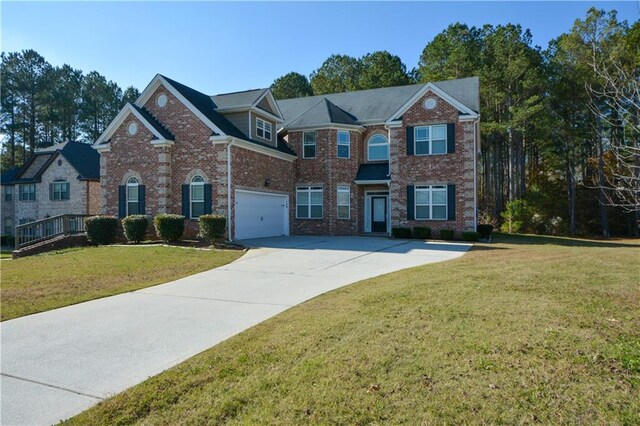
[0,1,640,94]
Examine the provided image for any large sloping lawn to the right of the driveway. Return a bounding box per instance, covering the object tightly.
[68,236,640,425]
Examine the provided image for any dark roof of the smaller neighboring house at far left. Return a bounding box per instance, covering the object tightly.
[13,141,100,183]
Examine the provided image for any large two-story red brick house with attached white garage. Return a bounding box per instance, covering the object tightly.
[95,74,480,239]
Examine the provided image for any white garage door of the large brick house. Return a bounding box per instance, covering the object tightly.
[235,190,289,240]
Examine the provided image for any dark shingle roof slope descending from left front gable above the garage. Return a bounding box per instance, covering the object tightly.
[162,76,295,155]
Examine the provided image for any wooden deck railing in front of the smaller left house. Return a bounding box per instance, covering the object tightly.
[15,214,87,250]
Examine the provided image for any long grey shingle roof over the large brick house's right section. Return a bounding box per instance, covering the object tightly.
[277,77,480,127]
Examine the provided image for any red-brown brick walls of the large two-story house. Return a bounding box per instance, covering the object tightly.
[101,80,475,238]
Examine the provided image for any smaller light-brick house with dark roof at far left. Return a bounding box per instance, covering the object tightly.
[2,142,100,235]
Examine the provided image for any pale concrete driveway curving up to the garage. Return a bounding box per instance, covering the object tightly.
[0,237,470,425]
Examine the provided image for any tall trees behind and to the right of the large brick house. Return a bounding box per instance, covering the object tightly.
[271,8,640,237]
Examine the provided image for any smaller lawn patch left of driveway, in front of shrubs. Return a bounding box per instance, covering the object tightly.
[0,246,244,321]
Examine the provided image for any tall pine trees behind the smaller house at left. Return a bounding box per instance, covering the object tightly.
[0,50,140,170]
